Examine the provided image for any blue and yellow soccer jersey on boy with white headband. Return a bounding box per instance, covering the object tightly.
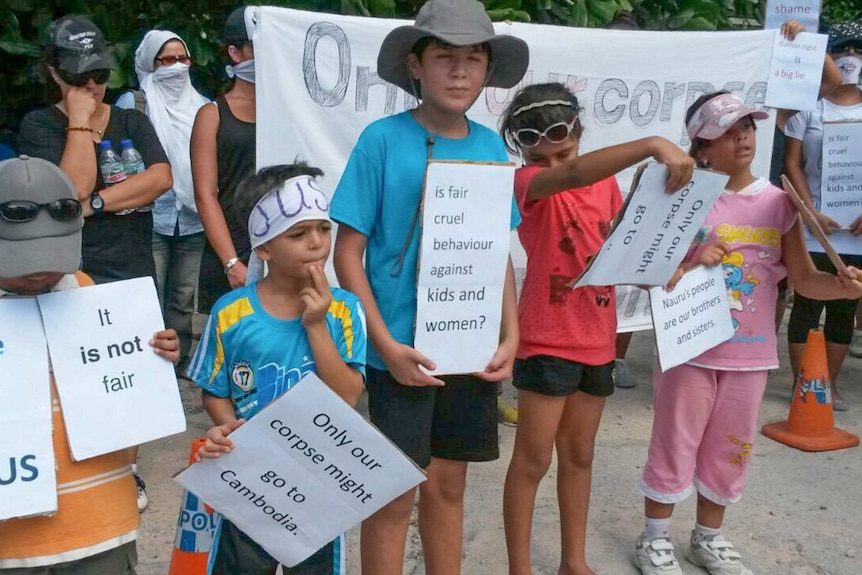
[187,284,366,419]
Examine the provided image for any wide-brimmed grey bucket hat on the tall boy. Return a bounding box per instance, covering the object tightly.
[377,0,530,97]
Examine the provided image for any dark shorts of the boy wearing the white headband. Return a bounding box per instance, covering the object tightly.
[212,517,344,575]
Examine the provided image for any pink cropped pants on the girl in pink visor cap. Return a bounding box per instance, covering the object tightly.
[640,364,769,505]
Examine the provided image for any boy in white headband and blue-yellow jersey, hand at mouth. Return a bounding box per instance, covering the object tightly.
[189,164,365,575]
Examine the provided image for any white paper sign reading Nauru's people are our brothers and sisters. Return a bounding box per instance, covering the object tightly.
[649,265,733,371]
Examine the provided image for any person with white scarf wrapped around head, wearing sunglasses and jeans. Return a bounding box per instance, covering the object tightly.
[117,30,207,373]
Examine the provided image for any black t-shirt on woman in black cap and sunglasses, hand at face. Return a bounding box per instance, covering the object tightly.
[21,106,168,283]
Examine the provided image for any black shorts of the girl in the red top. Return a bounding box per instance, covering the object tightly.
[512,355,614,397]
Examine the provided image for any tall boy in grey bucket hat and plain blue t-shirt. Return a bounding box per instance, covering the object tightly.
[331,0,529,575]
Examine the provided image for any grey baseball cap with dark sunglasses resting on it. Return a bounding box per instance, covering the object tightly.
[0,156,84,278]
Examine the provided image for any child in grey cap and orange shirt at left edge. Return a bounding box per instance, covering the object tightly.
[0,156,179,575]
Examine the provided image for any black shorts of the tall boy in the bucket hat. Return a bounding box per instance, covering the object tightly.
[365,367,500,469]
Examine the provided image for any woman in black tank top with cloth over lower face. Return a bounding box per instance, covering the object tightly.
[191,7,256,313]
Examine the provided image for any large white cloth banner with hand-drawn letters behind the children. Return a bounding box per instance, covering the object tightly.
[253,6,774,269]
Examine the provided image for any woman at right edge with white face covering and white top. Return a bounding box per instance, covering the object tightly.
[784,22,862,411]
